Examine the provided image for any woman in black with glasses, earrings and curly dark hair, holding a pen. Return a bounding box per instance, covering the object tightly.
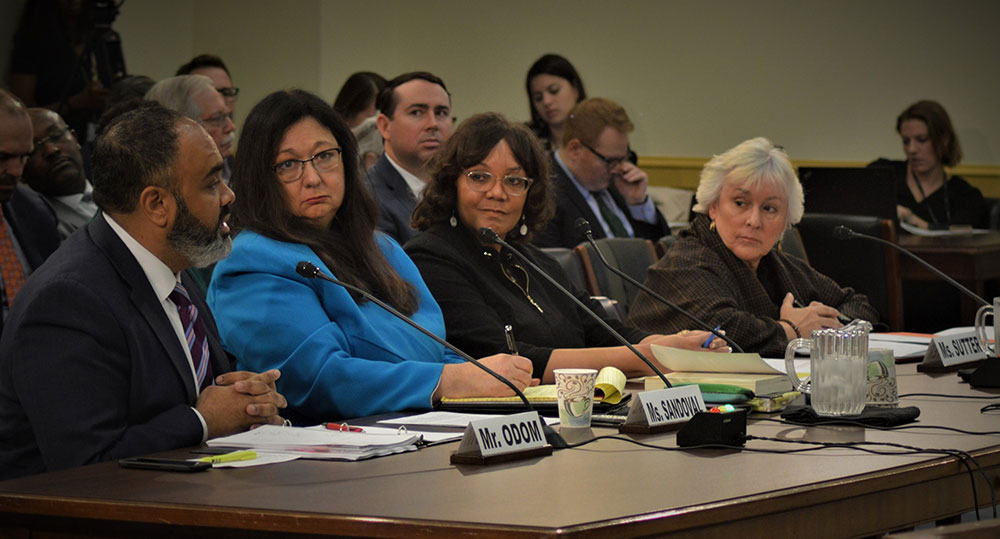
[406,114,728,383]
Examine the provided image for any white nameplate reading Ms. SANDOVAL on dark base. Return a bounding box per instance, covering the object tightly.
[618,385,705,434]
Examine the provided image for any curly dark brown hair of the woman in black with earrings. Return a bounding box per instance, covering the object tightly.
[410,112,555,241]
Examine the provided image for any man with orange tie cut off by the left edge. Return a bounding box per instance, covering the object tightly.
[0,89,59,331]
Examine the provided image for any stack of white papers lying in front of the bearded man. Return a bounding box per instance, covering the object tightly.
[207,425,420,460]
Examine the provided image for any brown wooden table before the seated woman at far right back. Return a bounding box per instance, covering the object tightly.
[899,232,1000,325]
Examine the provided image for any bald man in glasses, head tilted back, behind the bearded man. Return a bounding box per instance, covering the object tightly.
[24,108,97,239]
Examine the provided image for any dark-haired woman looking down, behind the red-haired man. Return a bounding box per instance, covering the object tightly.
[524,54,587,153]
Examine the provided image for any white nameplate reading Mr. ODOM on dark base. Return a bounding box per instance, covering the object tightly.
[456,412,545,457]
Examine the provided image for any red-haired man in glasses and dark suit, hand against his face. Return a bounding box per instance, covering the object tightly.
[534,97,670,248]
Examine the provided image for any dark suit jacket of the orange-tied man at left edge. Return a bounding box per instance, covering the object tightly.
[0,185,59,332]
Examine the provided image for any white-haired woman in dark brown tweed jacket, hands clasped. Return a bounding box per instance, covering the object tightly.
[628,137,878,357]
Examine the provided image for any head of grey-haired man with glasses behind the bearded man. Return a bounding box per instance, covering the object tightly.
[146,75,236,185]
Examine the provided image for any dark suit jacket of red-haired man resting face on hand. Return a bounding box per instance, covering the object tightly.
[532,158,670,249]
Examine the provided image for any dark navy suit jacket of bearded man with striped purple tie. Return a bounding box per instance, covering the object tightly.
[0,216,231,479]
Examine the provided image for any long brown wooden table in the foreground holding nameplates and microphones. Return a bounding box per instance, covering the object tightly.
[0,365,1000,538]
